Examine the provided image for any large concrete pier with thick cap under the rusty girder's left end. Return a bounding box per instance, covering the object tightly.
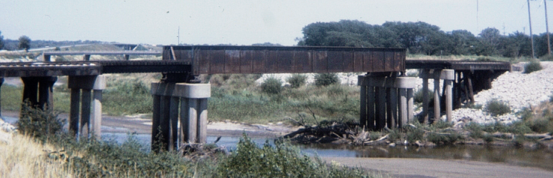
[151,82,211,151]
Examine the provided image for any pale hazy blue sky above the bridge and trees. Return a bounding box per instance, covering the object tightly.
[0,0,553,46]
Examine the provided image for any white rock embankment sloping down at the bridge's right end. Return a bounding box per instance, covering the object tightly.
[453,62,553,123]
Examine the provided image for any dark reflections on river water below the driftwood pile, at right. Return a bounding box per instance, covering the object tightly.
[300,144,553,170]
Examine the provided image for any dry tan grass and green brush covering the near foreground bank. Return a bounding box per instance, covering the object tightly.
[5,105,375,177]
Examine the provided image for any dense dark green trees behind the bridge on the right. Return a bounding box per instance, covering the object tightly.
[297,20,553,57]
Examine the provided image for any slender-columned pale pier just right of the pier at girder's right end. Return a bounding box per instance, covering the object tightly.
[420,69,455,123]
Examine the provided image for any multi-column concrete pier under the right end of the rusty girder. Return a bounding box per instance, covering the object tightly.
[358,75,415,130]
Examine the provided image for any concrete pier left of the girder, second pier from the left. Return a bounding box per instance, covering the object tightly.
[67,75,106,139]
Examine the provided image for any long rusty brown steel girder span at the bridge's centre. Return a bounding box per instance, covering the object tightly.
[162,46,405,75]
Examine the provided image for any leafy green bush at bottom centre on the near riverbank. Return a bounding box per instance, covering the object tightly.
[213,136,367,177]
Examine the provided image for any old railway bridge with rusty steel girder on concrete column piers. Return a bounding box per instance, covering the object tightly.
[0,46,510,150]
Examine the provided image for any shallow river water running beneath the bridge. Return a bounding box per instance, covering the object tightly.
[4,118,553,171]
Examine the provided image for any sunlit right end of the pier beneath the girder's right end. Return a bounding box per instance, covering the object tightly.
[395,77,416,128]
